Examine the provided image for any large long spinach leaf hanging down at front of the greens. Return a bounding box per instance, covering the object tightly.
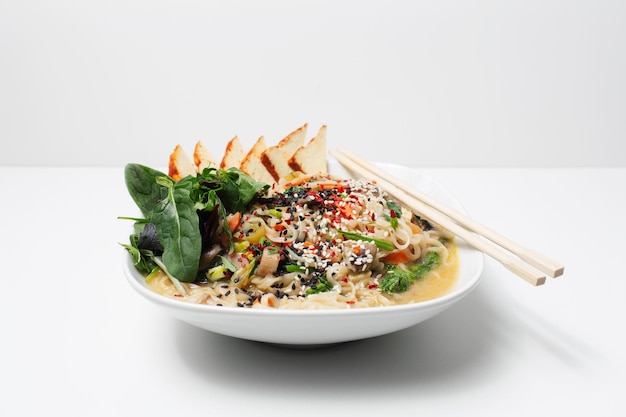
[152,177,202,282]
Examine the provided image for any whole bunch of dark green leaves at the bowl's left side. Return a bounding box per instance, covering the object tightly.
[120,164,269,282]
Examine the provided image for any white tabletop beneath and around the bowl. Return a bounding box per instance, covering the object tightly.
[0,167,626,416]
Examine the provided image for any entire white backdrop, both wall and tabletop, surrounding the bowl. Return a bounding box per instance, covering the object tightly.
[0,0,626,417]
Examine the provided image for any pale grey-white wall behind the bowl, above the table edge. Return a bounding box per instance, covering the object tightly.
[0,0,626,167]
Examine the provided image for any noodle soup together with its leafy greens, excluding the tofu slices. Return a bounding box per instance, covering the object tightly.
[123,164,457,309]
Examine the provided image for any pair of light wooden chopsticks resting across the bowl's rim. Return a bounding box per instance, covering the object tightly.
[330,148,564,286]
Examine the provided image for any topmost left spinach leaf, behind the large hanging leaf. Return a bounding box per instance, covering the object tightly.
[124,164,167,219]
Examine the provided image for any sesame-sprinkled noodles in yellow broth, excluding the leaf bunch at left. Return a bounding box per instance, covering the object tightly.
[147,175,458,309]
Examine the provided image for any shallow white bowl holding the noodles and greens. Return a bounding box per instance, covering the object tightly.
[123,161,484,346]
